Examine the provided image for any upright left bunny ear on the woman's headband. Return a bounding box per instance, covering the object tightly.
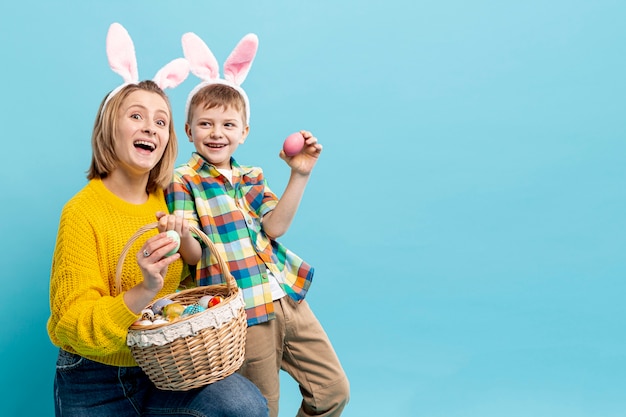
[106,23,139,83]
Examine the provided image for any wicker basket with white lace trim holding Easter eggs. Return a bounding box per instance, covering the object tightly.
[116,223,247,391]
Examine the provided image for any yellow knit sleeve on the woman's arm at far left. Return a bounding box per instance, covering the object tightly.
[48,202,137,356]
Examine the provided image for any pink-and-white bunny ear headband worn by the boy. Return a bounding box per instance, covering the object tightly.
[182,32,259,124]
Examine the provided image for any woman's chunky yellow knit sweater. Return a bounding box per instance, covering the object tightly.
[48,180,183,366]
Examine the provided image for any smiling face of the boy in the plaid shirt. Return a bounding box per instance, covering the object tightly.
[185,106,249,169]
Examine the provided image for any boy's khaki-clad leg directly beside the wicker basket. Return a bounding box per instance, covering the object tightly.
[239,316,284,417]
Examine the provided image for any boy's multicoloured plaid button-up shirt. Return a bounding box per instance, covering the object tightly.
[166,152,313,326]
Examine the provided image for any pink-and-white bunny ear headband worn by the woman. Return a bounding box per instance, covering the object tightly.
[102,23,189,110]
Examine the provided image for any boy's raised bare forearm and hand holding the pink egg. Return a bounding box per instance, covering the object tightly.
[263,130,322,239]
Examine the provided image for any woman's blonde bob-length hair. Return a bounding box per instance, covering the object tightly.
[87,80,178,193]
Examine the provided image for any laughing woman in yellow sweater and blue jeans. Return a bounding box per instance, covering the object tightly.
[48,76,267,417]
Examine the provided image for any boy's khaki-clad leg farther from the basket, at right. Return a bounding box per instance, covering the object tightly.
[276,297,350,417]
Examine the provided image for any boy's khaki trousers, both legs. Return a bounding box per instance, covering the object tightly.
[239,296,350,417]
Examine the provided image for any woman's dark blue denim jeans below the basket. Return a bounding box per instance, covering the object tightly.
[54,349,268,417]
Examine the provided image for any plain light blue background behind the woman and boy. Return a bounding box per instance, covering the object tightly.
[0,0,626,417]
